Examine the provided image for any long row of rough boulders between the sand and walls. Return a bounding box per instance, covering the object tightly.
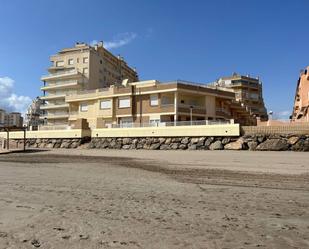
[9,135,309,151]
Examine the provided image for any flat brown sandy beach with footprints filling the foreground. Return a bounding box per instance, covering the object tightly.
[0,149,309,249]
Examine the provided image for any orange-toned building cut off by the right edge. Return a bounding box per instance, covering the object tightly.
[291,67,309,122]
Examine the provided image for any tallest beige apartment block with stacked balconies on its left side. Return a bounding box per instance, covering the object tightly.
[41,42,138,127]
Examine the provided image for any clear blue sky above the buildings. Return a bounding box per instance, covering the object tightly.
[0,0,309,117]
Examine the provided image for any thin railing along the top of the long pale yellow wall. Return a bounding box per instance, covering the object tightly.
[111,120,232,128]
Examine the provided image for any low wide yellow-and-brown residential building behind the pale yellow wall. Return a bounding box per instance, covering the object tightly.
[65,80,256,129]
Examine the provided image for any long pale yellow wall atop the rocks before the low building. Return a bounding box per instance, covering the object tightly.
[91,124,240,137]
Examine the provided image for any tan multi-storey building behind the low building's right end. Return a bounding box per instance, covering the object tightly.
[210,73,268,121]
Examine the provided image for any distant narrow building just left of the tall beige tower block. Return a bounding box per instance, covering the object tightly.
[25,97,43,131]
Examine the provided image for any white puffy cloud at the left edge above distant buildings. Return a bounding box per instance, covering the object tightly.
[0,77,32,113]
